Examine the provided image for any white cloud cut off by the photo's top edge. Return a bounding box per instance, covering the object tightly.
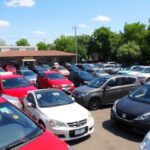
[5,0,35,7]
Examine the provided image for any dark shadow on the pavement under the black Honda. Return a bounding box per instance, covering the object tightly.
[102,120,144,143]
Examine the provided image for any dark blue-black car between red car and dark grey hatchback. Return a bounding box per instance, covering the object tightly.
[69,70,95,86]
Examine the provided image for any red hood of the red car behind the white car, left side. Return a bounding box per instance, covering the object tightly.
[3,86,36,98]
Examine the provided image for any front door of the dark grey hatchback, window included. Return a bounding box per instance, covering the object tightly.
[102,78,122,104]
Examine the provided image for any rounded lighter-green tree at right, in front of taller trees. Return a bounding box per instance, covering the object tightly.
[117,42,141,65]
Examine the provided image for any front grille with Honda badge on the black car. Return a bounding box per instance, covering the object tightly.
[116,110,137,121]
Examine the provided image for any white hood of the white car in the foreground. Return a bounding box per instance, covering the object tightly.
[40,102,88,123]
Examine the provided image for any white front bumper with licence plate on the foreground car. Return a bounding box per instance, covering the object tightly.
[46,120,94,141]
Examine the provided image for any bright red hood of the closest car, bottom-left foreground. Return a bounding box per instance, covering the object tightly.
[19,130,67,150]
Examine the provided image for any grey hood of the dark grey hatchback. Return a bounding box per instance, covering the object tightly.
[75,85,96,93]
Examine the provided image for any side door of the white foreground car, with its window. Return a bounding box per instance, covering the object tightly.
[24,93,40,121]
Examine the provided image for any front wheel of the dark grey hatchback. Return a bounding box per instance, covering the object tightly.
[88,98,101,110]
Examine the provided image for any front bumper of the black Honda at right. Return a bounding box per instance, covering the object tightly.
[111,109,150,134]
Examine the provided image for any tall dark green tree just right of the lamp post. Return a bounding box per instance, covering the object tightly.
[88,27,113,61]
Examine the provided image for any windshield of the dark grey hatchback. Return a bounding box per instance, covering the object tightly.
[88,77,108,88]
